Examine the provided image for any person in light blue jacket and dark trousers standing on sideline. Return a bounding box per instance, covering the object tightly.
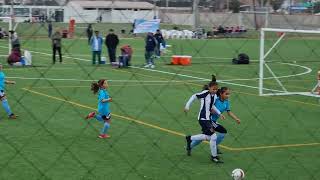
[90,31,103,65]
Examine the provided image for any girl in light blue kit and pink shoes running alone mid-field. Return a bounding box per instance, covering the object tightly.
[86,79,112,139]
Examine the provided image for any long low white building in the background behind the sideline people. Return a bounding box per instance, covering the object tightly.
[64,1,158,23]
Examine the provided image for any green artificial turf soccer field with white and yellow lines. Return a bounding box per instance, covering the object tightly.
[0,29,320,180]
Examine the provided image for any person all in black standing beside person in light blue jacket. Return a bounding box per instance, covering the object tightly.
[105,29,119,64]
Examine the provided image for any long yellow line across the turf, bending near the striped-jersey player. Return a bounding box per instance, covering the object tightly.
[22,88,320,151]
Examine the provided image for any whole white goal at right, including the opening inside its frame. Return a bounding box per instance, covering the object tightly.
[259,28,320,97]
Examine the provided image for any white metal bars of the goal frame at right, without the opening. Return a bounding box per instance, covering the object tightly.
[259,28,320,97]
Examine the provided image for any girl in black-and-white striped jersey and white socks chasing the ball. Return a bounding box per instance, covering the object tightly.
[184,76,222,163]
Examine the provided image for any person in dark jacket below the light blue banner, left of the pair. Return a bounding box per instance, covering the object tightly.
[144,32,157,68]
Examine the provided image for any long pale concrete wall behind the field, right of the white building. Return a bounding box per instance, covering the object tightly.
[159,12,320,29]
